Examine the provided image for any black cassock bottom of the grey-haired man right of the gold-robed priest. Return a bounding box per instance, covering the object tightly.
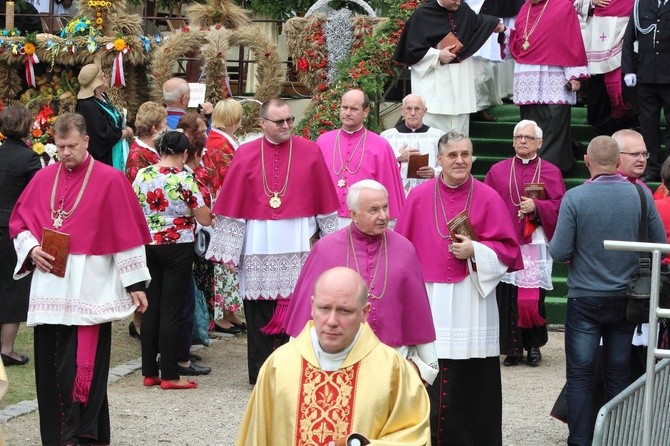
[428,356,502,446]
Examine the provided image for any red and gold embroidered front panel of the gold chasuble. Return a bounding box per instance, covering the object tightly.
[294,359,359,446]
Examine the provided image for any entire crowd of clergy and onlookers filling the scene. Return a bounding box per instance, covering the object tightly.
[0,0,670,446]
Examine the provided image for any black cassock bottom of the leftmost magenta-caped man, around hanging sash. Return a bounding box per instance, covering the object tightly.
[34,322,112,446]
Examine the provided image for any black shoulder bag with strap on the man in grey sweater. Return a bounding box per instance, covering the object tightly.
[626,184,670,324]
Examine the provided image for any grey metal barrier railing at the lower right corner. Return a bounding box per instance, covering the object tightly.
[593,240,670,446]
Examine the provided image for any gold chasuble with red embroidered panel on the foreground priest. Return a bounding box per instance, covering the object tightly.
[237,321,430,446]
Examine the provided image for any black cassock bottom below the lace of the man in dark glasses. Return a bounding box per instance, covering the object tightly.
[244,299,288,384]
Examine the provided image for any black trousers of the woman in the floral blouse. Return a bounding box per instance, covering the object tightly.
[141,243,195,380]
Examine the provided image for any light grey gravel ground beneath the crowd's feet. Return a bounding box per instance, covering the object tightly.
[0,331,567,446]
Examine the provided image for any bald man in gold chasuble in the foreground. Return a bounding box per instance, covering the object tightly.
[236,267,430,446]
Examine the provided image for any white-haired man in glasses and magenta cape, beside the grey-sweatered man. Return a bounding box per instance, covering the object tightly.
[484,120,565,366]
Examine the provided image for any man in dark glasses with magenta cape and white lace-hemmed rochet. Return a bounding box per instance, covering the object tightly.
[206,98,338,384]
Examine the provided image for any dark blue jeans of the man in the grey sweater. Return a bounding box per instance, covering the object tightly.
[565,296,635,446]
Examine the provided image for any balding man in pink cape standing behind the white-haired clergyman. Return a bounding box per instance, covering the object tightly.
[316,89,405,228]
